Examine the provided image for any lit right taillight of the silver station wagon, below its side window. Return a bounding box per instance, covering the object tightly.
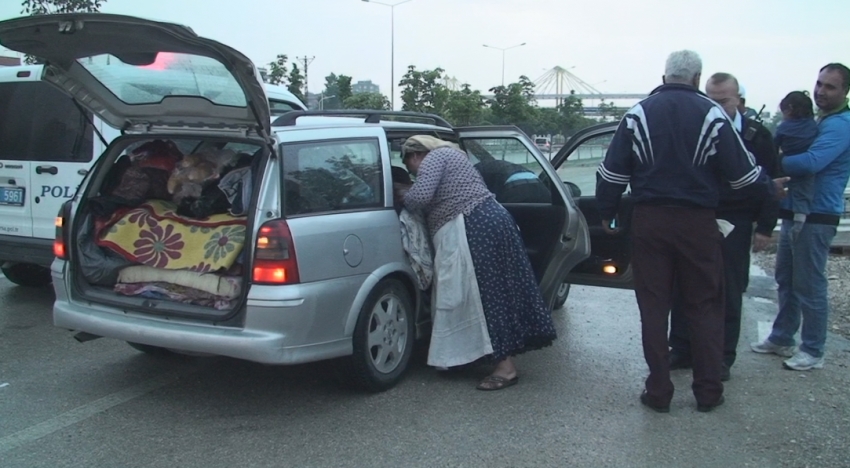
[253,219,300,284]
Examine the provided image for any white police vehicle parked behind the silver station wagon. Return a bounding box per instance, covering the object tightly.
[0,64,306,287]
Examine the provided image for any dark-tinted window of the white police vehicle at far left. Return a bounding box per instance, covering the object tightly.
[0,81,94,162]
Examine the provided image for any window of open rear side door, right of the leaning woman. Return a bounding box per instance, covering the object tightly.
[461,137,552,204]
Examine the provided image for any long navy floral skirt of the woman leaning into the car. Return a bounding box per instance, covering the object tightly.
[465,198,557,362]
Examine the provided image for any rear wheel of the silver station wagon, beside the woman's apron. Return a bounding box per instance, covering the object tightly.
[340,279,415,392]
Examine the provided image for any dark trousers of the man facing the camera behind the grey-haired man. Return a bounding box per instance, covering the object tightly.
[670,213,753,368]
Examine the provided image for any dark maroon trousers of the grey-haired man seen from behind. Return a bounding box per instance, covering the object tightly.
[632,205,724,406]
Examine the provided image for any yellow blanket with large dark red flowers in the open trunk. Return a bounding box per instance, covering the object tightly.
[97,200,246,272]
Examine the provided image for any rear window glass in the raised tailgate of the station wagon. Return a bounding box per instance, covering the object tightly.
[78,52,247,107]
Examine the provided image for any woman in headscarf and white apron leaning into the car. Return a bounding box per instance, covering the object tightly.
[394,135,556,390]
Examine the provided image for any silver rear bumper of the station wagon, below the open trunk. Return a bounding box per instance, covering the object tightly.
[52,261,362,364]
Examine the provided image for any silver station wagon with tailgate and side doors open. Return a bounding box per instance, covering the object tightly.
[0,14,631,391]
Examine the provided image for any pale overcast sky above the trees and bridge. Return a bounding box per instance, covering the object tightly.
[0,0,850,111]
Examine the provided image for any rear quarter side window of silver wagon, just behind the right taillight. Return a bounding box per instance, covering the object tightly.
[281,139,384,216]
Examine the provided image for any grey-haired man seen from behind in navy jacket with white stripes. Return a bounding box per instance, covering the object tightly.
[596,51,779,412]
